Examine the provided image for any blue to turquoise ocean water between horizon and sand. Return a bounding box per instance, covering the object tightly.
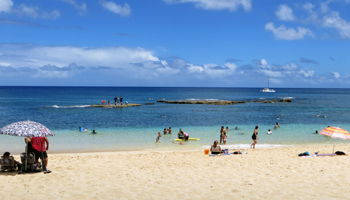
[0,87,350,153]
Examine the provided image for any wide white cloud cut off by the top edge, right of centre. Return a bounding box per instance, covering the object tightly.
[164,0,252,12]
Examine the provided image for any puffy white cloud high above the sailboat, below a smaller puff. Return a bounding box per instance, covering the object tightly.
[265,22,313,40]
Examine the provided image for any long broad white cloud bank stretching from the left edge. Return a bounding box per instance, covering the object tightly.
[0,44,159,72]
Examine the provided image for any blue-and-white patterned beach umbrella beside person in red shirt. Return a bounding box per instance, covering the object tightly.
[0,120,55,173]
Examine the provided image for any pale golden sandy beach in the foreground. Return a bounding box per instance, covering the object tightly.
[0,145,350,199]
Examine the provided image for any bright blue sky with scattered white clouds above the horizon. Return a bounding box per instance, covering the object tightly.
[0,0,350,88]
